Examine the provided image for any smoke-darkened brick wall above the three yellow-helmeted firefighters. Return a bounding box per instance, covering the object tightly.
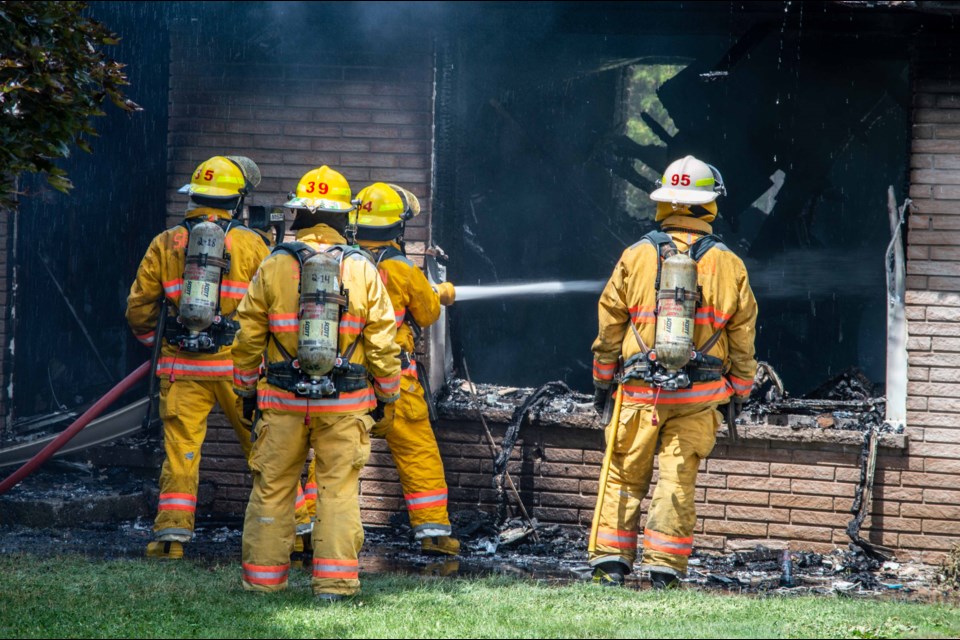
[167,34,433,253]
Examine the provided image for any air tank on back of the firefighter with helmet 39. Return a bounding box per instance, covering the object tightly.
[297,253,340,380]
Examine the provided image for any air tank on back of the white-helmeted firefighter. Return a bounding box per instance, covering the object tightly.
[654,253,698,372]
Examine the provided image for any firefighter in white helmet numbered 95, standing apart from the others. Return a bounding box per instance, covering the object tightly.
[590,156,757,588]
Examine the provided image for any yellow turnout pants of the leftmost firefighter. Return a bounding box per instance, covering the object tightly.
[153,377,251,541]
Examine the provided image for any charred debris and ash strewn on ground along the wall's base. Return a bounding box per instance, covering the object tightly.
[0,502,957,601]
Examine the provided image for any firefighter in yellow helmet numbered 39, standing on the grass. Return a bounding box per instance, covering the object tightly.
[233,166,400,602]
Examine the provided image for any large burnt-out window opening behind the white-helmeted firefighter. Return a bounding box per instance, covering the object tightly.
[442,25,909,408]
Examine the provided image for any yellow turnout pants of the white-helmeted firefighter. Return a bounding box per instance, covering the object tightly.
[590,404,720,577]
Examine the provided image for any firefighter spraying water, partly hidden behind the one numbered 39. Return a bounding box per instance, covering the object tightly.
[351,182,460,556]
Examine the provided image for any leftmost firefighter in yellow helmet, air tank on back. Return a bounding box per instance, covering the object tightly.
[126,156,268,558]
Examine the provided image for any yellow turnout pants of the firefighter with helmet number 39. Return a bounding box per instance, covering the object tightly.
[242,409,373,595]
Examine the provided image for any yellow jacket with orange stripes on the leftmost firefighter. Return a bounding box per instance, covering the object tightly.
[126,207,269,380]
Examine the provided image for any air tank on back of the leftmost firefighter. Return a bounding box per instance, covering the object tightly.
[180,222,225,333]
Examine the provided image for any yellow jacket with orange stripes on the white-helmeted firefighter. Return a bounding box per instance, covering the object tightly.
[593,215,757,404]
